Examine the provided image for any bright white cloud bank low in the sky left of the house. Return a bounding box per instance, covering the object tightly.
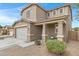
[0,11,19,26]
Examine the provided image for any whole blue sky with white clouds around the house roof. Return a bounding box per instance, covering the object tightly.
[0,3,79,27]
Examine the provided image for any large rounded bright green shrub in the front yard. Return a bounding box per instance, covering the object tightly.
[46,40,66,54]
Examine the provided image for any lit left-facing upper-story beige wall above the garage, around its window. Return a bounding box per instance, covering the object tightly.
[22,5,36,22]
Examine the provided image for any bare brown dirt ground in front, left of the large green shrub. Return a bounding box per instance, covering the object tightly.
[0,45,54,56]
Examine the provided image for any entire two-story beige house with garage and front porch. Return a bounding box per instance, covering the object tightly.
[14,4,72,42]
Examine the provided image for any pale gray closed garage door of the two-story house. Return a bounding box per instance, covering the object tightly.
[16,27,27,40]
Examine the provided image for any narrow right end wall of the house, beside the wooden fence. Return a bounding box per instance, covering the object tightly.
[65,7,72,41]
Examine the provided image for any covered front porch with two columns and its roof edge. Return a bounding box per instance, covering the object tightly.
[35,20,66,41]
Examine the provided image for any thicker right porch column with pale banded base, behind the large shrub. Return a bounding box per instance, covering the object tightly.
[57,21,64,41]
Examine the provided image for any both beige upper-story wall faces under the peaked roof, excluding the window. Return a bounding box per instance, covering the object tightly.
[22,5,46,22]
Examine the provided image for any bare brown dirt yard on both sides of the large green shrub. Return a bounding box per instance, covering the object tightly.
[0,41,79,56]
